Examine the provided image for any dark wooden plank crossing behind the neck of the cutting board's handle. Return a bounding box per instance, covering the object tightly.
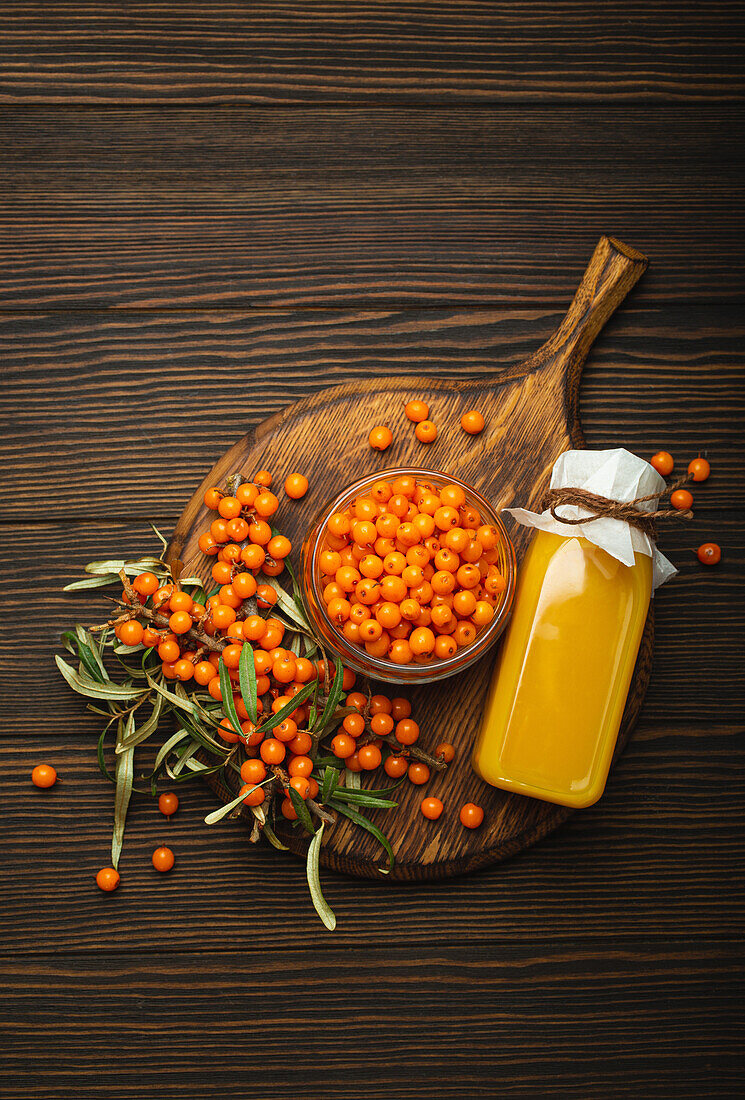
[0,305,745,523]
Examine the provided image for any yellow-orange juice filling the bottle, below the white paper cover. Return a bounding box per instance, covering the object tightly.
[473,531,653,807]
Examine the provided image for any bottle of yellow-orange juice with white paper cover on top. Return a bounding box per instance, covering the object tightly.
[472,450,675,807]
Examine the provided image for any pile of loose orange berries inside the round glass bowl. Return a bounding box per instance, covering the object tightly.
[318,475,506,664]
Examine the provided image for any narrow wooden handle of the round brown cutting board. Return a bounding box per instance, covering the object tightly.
[530,237,649,447]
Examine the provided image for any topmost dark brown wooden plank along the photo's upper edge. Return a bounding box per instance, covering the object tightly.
[1,0,744,103]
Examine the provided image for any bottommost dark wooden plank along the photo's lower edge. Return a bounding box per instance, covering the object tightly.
[0,936,742,1100]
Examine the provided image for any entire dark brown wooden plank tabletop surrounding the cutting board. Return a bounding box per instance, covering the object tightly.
[0,0,745,1100]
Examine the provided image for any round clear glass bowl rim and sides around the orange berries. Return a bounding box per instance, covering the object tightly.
[300,466,516,684]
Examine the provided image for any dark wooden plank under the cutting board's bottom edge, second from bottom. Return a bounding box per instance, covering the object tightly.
[0,721,745,955]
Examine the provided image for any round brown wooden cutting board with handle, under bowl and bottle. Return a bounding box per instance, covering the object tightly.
[168,237,653,881]
